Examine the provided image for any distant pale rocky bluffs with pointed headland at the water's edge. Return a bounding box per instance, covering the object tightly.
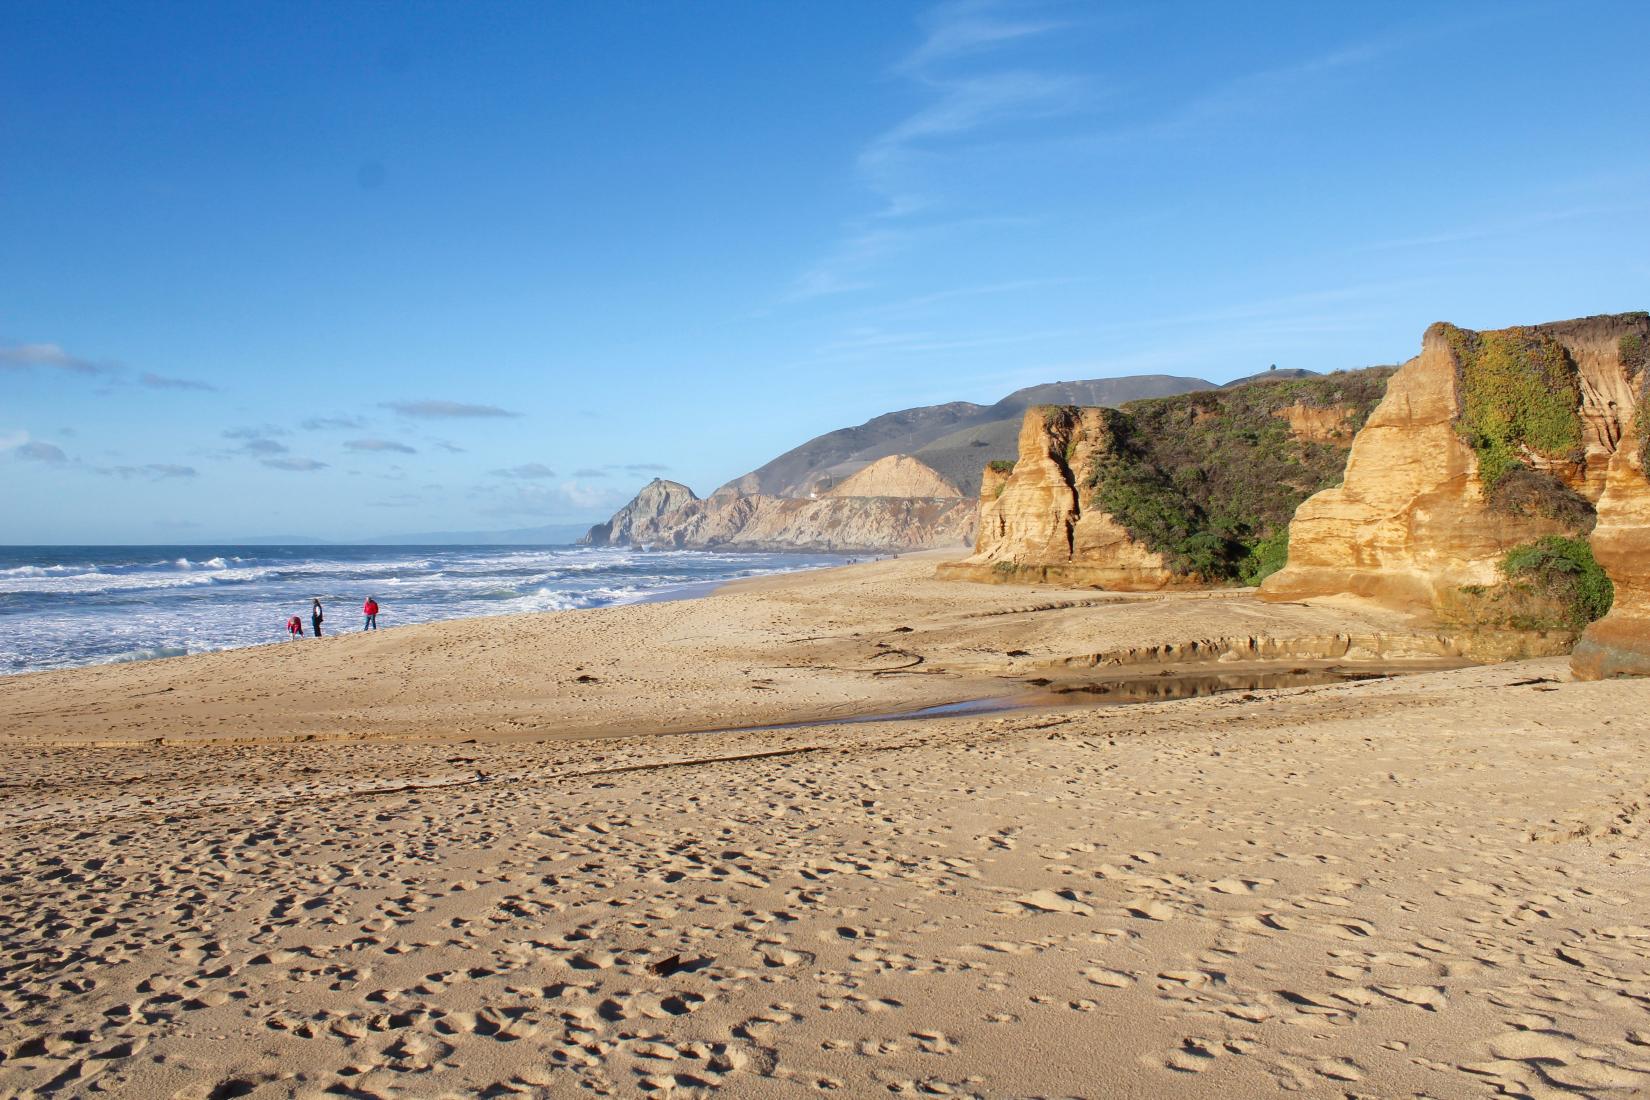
[579,455,975,552]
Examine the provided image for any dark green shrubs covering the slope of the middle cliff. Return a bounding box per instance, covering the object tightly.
[1082,366,1394,584]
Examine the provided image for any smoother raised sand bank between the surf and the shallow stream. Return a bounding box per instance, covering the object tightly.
[0,551,1537,745]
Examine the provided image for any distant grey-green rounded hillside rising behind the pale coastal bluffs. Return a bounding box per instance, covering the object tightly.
[716,374,1214,496]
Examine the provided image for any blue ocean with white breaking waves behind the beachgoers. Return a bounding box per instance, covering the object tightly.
[0,546,843,675]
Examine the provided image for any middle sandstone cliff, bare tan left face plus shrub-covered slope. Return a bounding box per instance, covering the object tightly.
[941,368,1391,590]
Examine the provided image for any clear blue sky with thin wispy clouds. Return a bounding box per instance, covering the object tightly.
[0,0,1650,543]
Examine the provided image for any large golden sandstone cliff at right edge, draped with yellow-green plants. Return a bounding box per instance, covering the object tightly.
[1262,313,1647,618]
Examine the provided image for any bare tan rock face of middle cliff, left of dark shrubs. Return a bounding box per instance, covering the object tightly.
[939,406,1181,592]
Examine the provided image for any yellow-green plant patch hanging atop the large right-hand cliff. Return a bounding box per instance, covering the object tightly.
[1444,325,1594,529]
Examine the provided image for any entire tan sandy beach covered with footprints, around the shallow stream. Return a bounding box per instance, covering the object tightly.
[0,554,1650,1100]
